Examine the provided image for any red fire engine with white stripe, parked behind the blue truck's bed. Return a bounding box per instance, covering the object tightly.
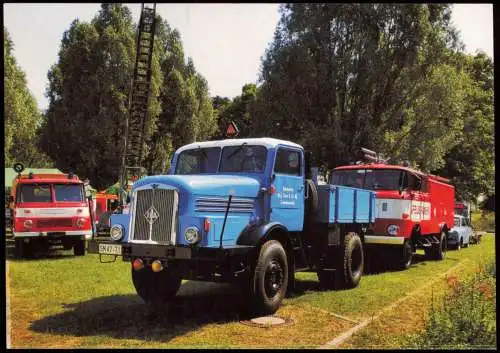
[330,148,455,269]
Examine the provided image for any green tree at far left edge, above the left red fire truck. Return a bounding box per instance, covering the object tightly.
[3,27,53,168]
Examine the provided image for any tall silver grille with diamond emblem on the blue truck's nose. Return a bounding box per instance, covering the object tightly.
[131,189,179,245]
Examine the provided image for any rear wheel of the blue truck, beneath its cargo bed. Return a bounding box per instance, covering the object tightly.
[336,232,364,288]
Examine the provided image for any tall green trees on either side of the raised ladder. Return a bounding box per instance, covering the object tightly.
[42,4,216,189]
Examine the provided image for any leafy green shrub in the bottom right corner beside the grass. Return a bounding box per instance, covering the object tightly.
[415,261,496,349]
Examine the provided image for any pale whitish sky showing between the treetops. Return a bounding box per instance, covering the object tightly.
[3,3,493,110]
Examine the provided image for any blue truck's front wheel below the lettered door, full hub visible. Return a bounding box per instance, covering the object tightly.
[251,240,289,315]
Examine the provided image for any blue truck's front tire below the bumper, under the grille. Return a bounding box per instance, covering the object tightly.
[131,267,182,305]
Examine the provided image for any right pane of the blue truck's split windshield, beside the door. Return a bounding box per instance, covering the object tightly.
[220,144,267,173]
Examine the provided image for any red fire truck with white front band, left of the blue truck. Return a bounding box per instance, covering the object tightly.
[9,163,92,257]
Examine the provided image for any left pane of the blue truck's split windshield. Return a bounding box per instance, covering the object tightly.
[175,147,220,175]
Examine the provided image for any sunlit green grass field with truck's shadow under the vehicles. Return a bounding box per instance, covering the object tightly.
[7,235,495,348]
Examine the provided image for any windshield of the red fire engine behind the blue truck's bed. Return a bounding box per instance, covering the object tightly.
[331,169,402,190]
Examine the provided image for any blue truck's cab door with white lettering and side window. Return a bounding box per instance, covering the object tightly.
[270,146,304,231]
